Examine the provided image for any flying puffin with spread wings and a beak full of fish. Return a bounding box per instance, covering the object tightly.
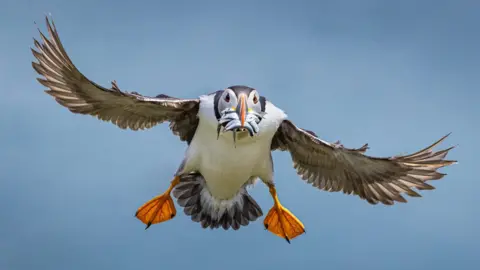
[32,17,456,243]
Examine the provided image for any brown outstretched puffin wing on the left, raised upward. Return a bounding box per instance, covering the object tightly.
[32,17,200,142]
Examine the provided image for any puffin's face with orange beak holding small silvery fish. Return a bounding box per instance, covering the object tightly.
[215,86,265,137]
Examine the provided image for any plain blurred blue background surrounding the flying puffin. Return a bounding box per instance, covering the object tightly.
[0,0,480,270]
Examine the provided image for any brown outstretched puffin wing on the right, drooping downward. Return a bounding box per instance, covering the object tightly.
[272,120,456,205]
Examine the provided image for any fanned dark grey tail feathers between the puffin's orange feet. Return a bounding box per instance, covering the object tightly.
[173,173,263,230]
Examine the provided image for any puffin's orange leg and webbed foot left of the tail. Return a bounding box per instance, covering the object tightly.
[135,176,180,230]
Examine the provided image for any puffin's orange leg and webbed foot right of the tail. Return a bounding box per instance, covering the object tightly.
[263,184,305,243]
